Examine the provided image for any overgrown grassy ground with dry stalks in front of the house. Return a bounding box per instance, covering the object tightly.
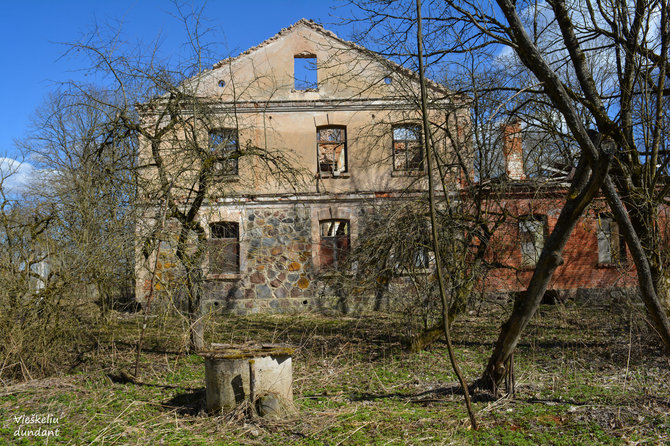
[0,303,670,445]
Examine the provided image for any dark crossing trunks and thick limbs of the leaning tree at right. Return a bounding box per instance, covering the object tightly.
[453,1,670,386]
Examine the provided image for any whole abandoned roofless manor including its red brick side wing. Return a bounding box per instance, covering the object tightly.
[136,19,635,314]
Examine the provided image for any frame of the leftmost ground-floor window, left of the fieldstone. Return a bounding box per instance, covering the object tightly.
[207,221,241,276]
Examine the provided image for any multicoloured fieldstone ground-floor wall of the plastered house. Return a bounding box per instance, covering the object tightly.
[203,203,430,314]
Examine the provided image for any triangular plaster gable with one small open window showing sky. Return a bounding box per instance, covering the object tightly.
[200,19,463,102]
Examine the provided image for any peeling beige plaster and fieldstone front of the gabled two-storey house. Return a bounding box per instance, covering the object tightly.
[136,19,469,314]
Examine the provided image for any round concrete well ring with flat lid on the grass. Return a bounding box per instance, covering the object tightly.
[200,344,294,416]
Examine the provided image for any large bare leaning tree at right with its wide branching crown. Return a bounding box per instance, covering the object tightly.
[346,0,670,389]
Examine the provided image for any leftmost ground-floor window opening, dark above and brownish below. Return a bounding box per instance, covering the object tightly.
[209,221,240,274]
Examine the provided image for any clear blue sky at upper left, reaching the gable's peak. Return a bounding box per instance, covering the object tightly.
[0,0,348,158]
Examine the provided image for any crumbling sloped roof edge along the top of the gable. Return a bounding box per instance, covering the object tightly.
[209,18,471,103]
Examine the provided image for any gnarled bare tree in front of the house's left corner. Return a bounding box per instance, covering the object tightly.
[57,5,302,350]
